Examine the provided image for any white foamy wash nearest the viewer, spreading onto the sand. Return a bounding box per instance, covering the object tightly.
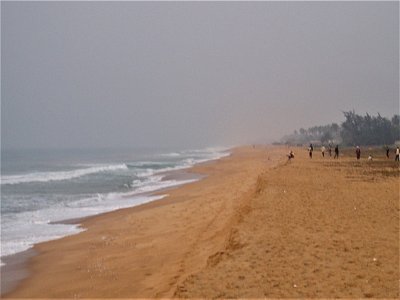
[0,193,165,264]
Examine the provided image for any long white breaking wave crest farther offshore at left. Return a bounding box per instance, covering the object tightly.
[1,164,128,184]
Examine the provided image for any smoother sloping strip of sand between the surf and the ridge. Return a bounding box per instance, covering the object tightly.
[4,147,282,298]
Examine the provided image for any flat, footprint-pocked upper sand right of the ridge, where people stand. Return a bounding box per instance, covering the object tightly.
[175,149,400,299]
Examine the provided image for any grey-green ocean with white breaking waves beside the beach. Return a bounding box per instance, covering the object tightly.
[0,148,229,265]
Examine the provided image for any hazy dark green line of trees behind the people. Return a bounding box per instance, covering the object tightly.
[281,110,400,146]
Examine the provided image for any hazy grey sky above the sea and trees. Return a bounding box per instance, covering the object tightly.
[1,1,399,148]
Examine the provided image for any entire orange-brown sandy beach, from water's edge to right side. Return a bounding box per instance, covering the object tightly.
[1,147,400,298]
